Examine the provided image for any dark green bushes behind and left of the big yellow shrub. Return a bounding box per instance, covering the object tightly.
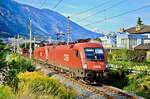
[4,53,35,91]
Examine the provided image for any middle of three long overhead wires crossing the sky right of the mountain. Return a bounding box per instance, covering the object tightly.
[78,0,125,21]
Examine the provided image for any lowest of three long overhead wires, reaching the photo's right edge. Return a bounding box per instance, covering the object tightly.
[84,4,150,26]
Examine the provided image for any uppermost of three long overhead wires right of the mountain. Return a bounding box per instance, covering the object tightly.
[71,0,112,17]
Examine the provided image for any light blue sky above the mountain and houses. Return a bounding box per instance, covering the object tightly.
[15,0,150,32]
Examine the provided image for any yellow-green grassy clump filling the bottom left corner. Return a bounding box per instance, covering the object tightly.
[0,85,15,99]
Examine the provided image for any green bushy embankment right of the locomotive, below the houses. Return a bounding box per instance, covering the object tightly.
[108,49,150,98]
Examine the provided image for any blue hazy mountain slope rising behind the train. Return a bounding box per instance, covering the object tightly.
[0,0,103,40]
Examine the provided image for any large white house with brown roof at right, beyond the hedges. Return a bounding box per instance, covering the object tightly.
[116,18,150,49]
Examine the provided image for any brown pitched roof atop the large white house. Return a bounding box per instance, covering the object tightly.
[125,25,150,34]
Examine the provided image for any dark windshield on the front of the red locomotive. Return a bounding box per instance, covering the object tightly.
[84,48,104,61]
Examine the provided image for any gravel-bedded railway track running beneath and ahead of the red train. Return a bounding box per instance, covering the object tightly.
[37,64,141,99]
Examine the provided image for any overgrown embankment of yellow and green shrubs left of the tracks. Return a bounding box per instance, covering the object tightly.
[0,43,76,99]
